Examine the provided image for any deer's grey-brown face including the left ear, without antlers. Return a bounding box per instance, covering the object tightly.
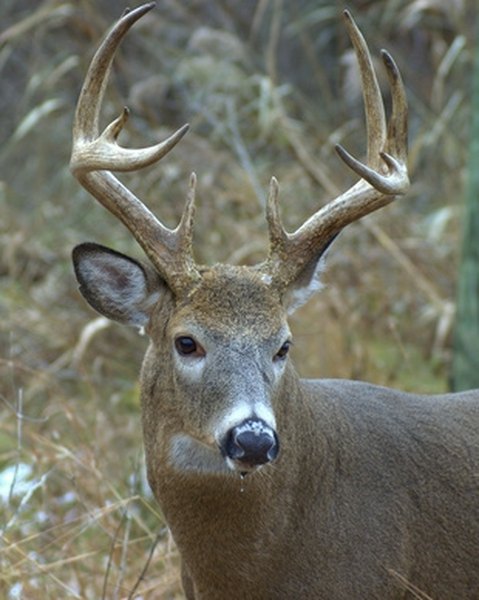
[74,244,291,472]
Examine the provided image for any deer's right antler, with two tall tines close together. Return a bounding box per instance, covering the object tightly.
[261,11,409,289]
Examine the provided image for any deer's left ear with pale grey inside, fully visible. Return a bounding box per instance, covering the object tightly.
[72,243,165,327]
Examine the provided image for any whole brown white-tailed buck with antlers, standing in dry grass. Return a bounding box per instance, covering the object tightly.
[71,3,479,600]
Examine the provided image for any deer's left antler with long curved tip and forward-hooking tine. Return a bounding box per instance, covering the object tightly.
[70,2,199,290]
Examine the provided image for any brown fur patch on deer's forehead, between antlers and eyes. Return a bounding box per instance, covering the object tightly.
[177,265,285,338]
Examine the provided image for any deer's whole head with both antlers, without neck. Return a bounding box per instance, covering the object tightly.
[71,3,409,478]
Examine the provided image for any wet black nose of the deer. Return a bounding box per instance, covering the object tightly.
[223,419,279,467]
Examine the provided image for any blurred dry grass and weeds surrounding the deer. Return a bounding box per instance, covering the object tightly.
[0,0,477,599]
